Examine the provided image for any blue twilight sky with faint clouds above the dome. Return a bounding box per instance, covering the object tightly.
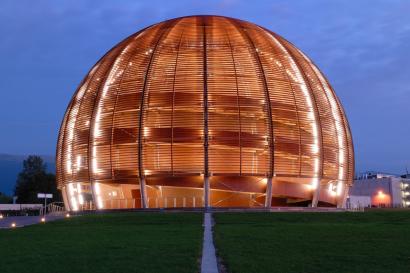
[0,0,410,173]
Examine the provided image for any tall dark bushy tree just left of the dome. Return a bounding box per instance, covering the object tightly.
[14,155,62,203]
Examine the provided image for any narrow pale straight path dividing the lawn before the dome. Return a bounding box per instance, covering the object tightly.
[201,212,218,273]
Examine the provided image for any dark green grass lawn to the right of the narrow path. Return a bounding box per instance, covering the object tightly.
[214,211,410,273]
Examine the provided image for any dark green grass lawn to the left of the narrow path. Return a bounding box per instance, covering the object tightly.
[0,213,203,273]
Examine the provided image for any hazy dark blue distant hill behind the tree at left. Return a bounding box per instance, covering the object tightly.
[0,154,55,195]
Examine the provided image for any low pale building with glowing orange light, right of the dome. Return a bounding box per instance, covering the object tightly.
[347,172,410,208]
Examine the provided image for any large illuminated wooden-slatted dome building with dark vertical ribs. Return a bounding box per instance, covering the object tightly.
[57,16,354,210]
